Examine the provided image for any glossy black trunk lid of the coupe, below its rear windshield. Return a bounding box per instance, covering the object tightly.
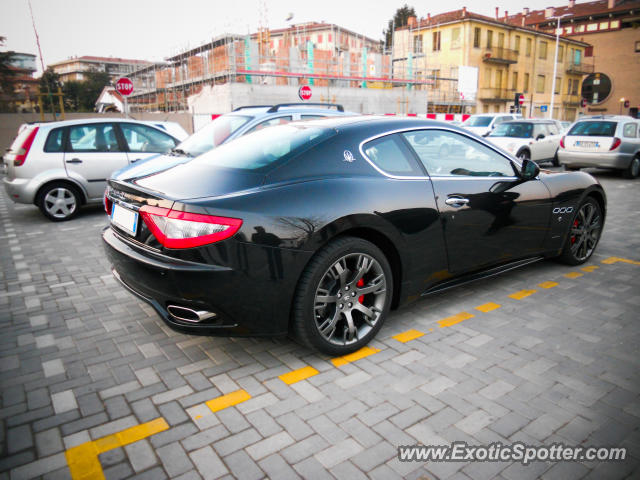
[128,162,265,200]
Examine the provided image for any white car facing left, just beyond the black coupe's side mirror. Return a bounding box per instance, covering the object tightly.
[487,119,562,166]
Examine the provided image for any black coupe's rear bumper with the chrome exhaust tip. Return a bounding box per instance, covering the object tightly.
[102,228,308,336]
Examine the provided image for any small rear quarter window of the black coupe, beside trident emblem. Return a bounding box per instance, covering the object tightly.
[363,135,424,177]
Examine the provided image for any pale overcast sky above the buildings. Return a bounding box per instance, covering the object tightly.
[0,0,568,74]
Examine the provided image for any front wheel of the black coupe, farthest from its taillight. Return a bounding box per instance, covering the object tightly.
[558,197,602,265]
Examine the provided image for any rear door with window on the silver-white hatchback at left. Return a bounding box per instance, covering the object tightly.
[64,123,129,200]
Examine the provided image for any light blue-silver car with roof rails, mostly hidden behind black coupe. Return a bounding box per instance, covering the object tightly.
[113,103,355,179]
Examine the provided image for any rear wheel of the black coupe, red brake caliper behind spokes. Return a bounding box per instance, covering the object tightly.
[292,237,393,356]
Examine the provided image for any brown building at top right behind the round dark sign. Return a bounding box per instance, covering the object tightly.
[508,0,640,117]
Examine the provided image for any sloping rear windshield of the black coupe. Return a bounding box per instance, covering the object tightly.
[193,124,336,172]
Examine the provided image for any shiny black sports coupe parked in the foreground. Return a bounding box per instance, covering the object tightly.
[103,116,606,355]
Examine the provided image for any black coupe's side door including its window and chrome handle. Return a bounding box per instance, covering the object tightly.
[402,129,551,274]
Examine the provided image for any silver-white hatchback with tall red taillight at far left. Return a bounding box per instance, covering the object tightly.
[3,118,179,221]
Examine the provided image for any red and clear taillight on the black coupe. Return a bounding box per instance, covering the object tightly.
[140,205,242,248]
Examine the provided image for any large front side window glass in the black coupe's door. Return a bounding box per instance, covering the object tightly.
[402,130,515,177]
